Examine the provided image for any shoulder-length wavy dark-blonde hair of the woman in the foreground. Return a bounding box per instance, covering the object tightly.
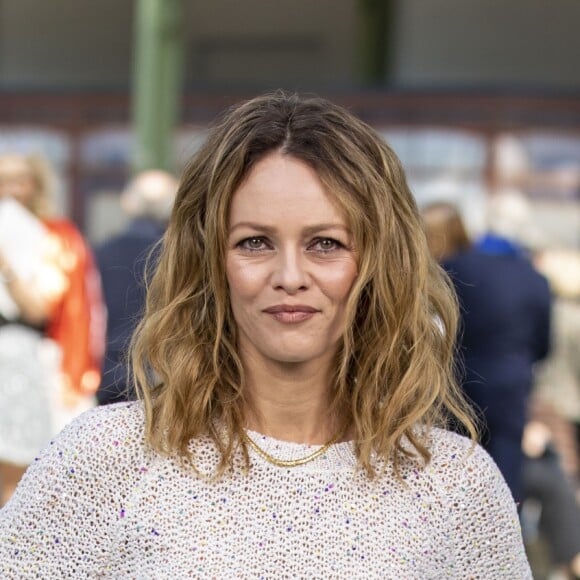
[132,92,476,477]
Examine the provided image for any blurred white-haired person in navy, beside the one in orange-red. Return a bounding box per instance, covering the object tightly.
[96,170,177,405]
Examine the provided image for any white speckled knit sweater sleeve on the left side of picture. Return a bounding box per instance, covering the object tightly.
[0,403,145,578]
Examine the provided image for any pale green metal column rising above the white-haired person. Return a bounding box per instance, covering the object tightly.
[132,0,183,172]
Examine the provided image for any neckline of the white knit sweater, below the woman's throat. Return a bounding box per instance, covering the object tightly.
[245,429,357,471]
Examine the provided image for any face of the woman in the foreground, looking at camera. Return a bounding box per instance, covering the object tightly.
[226,152,357,364]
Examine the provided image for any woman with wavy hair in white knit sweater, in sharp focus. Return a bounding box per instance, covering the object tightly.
[0,93,529,578]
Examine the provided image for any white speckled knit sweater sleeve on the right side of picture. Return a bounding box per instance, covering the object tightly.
[446,436,532,579]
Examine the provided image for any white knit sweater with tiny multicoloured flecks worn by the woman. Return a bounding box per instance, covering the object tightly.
[0,403,531,580]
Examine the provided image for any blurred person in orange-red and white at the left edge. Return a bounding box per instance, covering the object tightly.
[0,154,105,504]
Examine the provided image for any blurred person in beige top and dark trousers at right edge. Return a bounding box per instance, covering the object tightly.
[524,249,580,578]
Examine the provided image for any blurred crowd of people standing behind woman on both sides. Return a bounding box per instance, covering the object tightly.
[0,138,580,578]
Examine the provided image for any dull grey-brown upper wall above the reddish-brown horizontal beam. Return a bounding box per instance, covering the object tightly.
[0,0,580,91]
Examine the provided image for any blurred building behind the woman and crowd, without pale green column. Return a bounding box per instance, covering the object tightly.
[0,0,580,247]
